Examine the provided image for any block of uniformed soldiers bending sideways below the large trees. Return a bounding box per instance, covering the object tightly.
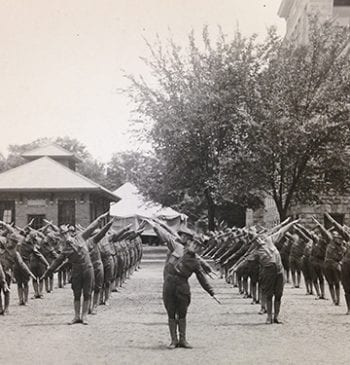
[203,213,350,323]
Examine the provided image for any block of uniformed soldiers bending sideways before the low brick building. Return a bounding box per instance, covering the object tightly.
[0,213,144,324]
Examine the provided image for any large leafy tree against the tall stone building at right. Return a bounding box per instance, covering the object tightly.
[221,18,350,219]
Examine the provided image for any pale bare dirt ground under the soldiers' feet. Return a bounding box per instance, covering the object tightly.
[0,246,350,365]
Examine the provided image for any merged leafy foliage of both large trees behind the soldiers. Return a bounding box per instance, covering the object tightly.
[127,19,350,229]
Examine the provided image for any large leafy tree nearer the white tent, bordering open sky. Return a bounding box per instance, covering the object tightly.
[128,28,256,229]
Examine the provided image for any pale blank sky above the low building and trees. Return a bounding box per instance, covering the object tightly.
[0,0,285,162]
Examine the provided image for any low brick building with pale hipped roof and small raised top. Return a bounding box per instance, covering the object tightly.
[0,144,120,227]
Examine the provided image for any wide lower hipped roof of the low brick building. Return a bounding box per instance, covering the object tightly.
[0,157,120,202]
